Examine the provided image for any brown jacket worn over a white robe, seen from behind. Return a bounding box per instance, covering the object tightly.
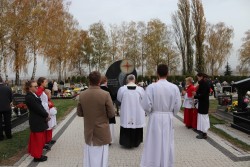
[77,86,115,146]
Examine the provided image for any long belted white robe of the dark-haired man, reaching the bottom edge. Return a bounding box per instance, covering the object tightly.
[140,79,181,167]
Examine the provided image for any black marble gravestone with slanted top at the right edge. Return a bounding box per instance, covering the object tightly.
[232,78,250,134]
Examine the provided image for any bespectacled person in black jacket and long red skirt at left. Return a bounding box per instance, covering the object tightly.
[25,81,49,162]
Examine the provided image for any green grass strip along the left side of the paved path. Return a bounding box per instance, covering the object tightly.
[0,99,77,166]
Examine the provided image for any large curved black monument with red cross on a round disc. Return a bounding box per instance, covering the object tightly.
[106,59,137,100]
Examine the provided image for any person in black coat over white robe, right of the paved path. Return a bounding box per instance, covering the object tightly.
[194,73,210,139]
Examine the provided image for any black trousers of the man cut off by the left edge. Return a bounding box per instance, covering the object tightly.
[0,110,12,139]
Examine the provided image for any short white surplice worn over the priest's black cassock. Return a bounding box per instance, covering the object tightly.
[117,84,145,129]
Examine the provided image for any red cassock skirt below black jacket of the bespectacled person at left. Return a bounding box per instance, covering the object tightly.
[28,132,45,158]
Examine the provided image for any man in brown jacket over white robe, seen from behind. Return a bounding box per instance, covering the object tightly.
[77,71,115,167]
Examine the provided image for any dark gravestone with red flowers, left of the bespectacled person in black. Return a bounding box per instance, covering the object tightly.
[13,94,27,116]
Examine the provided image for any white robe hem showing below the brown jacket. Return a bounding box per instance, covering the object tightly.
[83,144,109,167]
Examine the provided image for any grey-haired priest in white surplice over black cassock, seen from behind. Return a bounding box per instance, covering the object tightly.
[117,74,145,148]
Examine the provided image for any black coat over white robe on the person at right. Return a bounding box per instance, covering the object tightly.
[194,79,210,114]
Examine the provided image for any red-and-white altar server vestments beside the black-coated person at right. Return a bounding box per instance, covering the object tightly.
[184,84,195,127]
